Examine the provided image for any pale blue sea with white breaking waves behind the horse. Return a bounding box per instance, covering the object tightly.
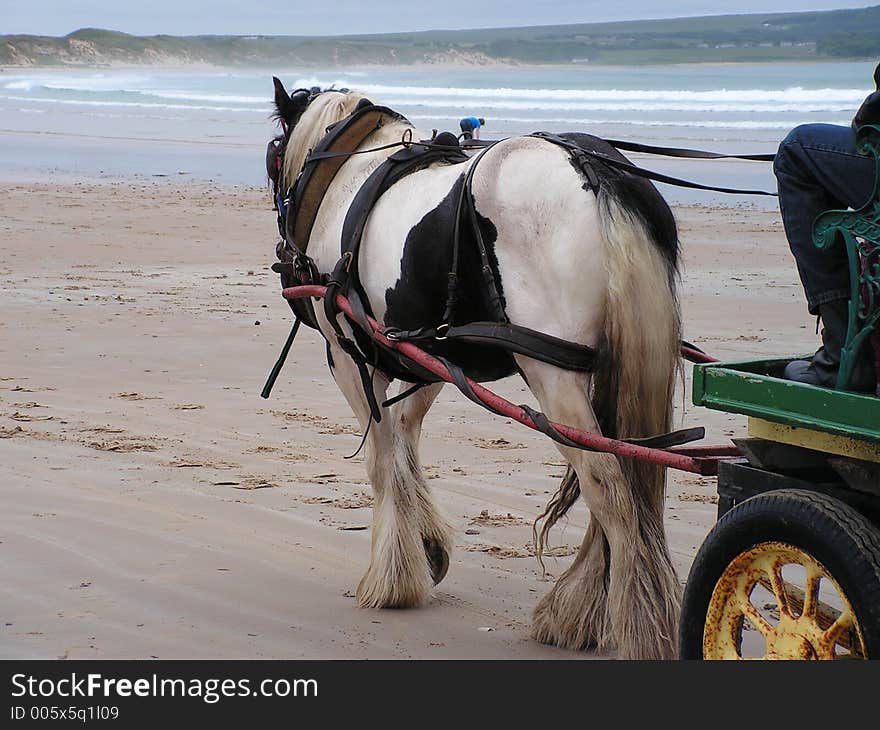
[0,61,875,207]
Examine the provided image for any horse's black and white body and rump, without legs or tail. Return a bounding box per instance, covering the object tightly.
[361,134,677,356]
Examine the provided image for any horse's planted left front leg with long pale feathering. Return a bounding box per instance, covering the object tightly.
[330,345,434,608]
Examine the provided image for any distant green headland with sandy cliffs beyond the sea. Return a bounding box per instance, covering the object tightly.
[0,5,880,68]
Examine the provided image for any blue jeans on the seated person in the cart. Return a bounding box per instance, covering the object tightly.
[773,124,874,314]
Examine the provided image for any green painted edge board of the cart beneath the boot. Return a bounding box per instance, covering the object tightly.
[693,359,880,442]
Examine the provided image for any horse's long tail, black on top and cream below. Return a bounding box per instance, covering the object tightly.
[535,180,681,556]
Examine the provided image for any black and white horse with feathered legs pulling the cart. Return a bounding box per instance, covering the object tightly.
[274,78,681,659]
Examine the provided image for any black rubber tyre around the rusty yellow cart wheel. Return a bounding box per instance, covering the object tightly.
[679,489,880,659]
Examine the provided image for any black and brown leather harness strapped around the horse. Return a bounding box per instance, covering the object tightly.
[262,99,701,448]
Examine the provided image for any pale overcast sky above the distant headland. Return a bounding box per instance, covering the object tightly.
[0,0,877,36]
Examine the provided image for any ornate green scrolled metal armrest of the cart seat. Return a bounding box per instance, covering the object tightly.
[813,124,880,390]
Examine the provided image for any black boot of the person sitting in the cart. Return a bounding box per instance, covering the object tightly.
[783,299,877,393]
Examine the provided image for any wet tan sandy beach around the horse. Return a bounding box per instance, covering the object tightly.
[0,180,816,659]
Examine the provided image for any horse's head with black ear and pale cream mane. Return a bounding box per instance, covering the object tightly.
[266,76,363,190]
